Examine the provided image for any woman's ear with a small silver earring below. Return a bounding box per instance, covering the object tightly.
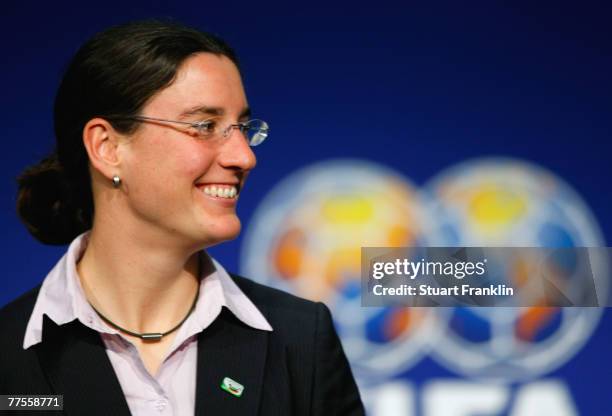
[83,118,121,181]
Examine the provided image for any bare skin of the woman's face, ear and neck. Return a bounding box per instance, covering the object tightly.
[77,53,256,374]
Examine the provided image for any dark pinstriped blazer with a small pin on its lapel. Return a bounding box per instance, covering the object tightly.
[0,275,364,416]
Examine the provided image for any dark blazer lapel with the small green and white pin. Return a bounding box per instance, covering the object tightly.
[195,308,268,416]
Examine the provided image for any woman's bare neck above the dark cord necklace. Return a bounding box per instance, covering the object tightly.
[77,227,200,332]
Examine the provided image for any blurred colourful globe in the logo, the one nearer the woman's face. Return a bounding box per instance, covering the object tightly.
[241,160,438,383]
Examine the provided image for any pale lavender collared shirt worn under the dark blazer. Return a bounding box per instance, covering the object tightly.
[23,233,272,416]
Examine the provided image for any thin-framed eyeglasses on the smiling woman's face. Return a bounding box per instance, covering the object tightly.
[107,116,270,146]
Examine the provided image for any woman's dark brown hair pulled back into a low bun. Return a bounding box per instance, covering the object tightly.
[17,21,238,244]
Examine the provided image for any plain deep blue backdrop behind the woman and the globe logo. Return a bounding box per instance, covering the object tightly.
[0,1,612,414]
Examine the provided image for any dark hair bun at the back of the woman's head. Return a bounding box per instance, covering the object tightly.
[17,153,87,245]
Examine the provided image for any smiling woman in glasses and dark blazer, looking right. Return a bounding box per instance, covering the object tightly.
[0,22,363,415]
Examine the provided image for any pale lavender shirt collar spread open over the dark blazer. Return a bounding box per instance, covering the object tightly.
[23,232,272,349]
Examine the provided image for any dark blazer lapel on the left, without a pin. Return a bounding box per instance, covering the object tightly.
[35,315,130,416]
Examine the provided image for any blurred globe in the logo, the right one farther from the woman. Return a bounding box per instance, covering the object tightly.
[424,159,608,380]
